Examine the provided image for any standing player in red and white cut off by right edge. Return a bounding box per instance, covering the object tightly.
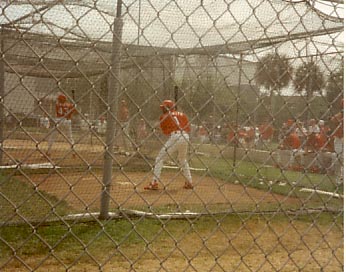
[331,99,344,184]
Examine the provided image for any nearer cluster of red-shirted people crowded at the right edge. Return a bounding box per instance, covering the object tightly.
[278,103,344,183]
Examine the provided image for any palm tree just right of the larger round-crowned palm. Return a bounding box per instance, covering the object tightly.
[293,60,324,119]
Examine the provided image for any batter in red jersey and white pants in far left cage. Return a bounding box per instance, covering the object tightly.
[46,94,77,157]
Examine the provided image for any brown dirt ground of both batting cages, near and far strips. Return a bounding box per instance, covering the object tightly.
[5,140,301,212]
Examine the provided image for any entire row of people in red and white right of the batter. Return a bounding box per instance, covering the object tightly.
[196,106,344,183]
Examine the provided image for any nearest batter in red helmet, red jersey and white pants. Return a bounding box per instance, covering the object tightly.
[144,100,193,190]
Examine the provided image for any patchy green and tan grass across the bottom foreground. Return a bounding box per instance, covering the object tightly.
[0,213,343,271]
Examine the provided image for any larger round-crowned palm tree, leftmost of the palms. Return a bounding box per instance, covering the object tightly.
[255,53,292,116]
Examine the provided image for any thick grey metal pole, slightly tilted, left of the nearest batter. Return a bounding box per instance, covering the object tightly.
[99,0,123,220]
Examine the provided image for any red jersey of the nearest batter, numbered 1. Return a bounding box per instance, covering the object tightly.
[160,111,191,135]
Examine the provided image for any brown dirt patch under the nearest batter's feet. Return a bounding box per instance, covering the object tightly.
[16,171,299,212]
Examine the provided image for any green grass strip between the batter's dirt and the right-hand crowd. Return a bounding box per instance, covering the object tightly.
[192,154,344,209]
